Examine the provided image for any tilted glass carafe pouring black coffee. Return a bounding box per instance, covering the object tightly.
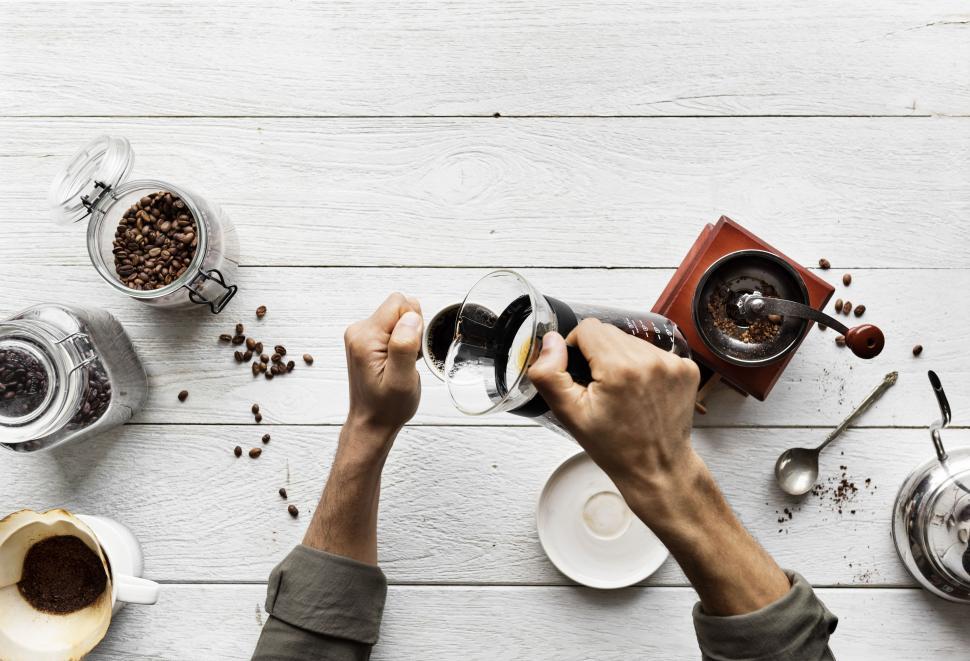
[432,269,690,436]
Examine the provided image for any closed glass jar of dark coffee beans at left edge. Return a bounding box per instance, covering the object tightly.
[0,304,148,452]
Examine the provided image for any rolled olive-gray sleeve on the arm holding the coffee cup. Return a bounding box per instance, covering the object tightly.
[253,545,387,661]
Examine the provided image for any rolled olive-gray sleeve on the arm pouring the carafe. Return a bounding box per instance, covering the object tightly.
[694,571,839,661]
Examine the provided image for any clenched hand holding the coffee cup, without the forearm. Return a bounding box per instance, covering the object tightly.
[344,293,423,458]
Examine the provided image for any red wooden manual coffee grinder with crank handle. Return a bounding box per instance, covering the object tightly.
[653,216,885,401]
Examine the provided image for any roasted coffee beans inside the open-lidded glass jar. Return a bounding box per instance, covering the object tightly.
[112,191,199,291]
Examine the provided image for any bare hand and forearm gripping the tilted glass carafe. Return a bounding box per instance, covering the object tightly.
[529,319,790,615]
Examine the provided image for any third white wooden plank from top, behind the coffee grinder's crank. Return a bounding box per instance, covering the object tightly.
[0,265,970,426]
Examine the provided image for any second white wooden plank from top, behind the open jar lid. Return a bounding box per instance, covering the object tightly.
[0,116,970,268]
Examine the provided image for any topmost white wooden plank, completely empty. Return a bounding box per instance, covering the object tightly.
[0,0,970,115]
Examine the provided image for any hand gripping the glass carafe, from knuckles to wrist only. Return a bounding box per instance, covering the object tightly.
[529,319,700,502]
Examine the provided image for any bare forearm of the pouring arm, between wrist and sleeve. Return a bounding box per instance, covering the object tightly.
[625,452,790,615]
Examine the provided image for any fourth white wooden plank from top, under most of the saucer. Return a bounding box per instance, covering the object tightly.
[0,422,970,586]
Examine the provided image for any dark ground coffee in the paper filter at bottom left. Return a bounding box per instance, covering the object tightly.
[17,535,108,615]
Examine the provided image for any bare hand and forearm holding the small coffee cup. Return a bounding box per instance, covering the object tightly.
[303,294,422,564]
